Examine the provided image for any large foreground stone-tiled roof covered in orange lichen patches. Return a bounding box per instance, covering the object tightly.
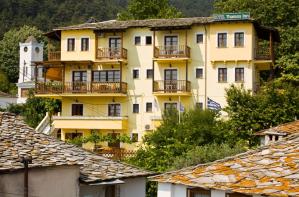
[150,134,299,196]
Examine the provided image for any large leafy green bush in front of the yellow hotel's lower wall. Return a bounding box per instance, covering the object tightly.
[130,109,244,172]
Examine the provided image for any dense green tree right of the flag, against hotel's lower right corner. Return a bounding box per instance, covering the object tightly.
[224,82,299,146]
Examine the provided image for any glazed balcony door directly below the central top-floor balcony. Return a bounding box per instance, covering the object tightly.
[164,69,178,92]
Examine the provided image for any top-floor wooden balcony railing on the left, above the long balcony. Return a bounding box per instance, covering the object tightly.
[96,48,128,59]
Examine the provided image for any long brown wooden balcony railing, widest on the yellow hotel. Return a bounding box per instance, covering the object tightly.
[36,82,127,94]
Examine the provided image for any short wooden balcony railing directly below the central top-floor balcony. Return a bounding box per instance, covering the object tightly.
[154,80,191,93]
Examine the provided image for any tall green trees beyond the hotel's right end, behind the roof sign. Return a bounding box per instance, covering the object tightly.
[214,0,299,85]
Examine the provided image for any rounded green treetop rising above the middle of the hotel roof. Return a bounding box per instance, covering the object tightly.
[118,0,182,20]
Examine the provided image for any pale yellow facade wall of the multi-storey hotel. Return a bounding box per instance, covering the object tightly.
[41,22,268,149]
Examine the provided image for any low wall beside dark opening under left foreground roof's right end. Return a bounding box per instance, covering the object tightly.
[80,177,145,197]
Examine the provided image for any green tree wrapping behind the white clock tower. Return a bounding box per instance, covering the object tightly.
[0,25,45,83]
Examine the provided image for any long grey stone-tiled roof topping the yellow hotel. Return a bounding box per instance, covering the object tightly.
[54,17,229,30]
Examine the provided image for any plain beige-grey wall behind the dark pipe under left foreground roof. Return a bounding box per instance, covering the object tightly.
[0,166,79,197]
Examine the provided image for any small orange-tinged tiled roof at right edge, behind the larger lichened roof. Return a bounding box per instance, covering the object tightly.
[255,120,299,136]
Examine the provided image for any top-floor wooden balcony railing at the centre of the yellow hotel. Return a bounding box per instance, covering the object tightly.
[154,45,190,58]
